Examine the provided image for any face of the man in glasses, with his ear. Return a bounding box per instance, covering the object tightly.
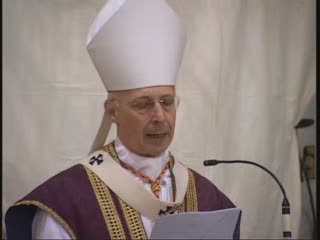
[105,86,176,157]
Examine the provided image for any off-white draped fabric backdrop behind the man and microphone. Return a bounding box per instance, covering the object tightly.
[3,0,316,238]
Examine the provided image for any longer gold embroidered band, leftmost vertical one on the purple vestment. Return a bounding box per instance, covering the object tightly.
[85,167,126,239]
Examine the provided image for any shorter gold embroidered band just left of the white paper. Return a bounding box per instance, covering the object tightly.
[119,198,147,239]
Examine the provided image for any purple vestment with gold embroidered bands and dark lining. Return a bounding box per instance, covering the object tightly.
[6,143,241,240]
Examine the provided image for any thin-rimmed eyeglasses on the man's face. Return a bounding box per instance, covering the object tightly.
[130,95,180,114]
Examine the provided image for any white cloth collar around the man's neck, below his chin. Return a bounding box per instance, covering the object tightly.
[115,137,169,180]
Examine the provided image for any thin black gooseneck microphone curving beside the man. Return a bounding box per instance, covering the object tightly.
[203,159,291,239]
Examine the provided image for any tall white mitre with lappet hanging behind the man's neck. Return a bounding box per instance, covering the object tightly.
[87,0,186,152]
